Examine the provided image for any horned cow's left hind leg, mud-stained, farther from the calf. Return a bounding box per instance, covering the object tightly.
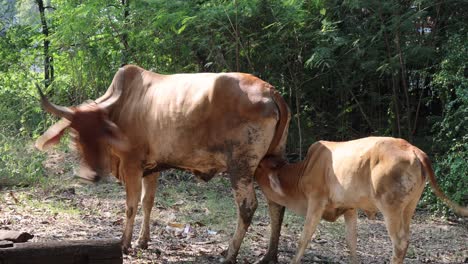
[224,174,257,263]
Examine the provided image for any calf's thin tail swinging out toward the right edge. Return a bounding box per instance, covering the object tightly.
[414,149,468,216]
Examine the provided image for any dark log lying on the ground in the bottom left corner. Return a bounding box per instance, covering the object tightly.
[0,240,122,264]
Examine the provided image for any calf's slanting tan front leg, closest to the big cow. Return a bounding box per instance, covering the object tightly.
[291,198,325,264]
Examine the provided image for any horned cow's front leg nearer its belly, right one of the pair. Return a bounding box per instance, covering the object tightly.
[137,172,159,249]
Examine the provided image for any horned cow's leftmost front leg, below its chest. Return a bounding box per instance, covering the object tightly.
[121,161,143,254]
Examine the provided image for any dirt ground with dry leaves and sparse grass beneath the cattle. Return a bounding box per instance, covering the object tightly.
[0,152,468,263]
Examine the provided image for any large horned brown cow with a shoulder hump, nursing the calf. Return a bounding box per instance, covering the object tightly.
[36,65,290,263]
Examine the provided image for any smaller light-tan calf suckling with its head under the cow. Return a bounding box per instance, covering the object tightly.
[255,137,468,264]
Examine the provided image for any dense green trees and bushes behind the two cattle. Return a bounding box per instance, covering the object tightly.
[0,0,468,212]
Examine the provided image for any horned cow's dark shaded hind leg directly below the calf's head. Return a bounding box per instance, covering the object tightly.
[258,199,285,264]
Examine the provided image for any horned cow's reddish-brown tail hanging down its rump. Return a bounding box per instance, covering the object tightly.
[266,87,291,156]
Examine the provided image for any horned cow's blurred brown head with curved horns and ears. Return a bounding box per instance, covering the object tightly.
[36,71,128,181]
